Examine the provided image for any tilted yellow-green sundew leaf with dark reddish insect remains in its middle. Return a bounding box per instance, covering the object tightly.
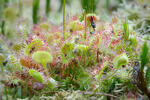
[25,39,43,56]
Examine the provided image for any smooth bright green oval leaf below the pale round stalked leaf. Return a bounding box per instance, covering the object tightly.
[29,69,43,83]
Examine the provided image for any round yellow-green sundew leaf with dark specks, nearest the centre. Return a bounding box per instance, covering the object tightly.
[61,43,74,63]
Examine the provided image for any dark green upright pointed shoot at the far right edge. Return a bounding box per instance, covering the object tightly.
[140,42,149,69]
